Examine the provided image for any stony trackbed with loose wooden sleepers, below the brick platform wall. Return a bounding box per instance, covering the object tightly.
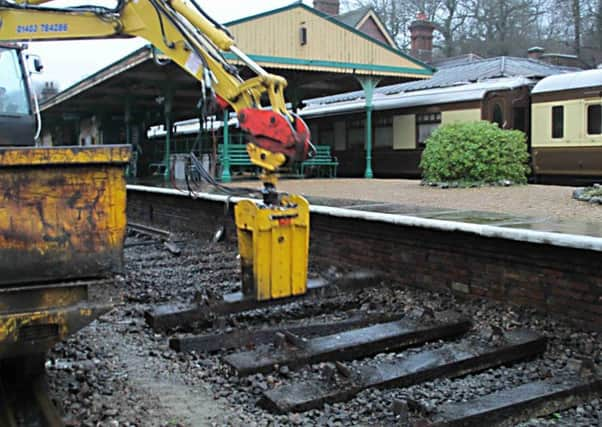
[39,222,602,426]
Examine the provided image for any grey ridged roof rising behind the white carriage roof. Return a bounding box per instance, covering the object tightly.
[305,56,576,105]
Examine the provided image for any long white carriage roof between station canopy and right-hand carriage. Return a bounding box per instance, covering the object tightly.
[300,77,535,118]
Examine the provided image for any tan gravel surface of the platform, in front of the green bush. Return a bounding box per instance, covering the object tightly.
[231,179,602,222]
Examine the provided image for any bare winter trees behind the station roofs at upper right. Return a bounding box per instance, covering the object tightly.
[343,0,602,65]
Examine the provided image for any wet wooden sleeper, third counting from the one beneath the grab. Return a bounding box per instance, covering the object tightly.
[224,312,472,376]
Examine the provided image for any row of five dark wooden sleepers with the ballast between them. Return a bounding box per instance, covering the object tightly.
[115,226,602,426]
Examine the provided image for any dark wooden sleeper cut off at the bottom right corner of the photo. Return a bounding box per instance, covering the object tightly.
[414,376,602,427]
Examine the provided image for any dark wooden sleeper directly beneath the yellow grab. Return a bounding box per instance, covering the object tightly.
[144,270,383,332]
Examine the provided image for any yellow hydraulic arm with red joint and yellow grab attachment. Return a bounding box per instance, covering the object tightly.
[0,0,311,300]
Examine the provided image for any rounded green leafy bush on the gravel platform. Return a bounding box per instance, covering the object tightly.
[420,121,530,184]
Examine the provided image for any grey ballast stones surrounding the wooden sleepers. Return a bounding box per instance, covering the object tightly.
[47,237,602,427]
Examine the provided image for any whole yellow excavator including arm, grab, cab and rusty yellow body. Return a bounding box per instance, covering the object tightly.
[0,0,313,426]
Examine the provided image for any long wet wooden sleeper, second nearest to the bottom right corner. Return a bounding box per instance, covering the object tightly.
[258,330,547,413]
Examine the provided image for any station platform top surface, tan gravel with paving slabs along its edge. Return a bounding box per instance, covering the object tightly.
[127,179,602,241]
